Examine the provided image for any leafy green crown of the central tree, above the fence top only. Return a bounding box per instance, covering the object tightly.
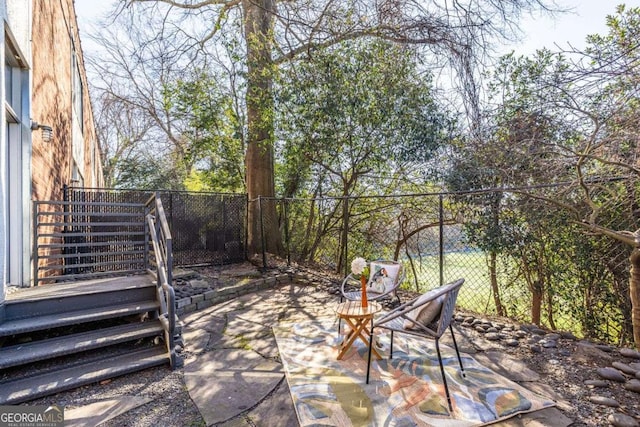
[277,39,452,196]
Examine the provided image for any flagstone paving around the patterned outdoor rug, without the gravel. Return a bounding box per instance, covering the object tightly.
[67,283,571,427]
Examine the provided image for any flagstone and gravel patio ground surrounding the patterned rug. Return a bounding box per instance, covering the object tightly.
[25,262,637,426]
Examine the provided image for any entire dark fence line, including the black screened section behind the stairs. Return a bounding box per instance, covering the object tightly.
[62,183,638,343]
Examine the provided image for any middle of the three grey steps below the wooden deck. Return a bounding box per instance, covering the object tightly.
[0,320,163,369]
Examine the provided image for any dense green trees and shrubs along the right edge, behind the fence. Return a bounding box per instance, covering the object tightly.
[448,6,640,341]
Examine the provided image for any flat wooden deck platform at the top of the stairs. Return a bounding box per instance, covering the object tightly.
[6,274,155,302]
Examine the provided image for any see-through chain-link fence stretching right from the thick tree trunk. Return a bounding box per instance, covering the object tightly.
[262,186,637,343]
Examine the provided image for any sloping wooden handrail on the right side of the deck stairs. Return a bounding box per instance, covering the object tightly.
[145,192,177,368]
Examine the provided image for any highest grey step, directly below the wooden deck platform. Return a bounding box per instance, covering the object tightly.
[0,300,159,337]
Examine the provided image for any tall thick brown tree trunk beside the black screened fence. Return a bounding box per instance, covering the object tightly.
[243,0,284,255]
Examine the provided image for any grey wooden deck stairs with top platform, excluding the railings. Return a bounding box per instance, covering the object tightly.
[0,274,179,405]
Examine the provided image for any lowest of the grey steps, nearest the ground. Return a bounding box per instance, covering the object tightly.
[0,346,169,405]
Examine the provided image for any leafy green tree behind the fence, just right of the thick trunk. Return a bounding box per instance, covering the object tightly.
[276,38,453,268]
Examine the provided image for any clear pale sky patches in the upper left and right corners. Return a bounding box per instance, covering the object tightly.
[75,0,640,55]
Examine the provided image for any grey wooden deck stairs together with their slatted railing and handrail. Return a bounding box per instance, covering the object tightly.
[0,193,182,405]
